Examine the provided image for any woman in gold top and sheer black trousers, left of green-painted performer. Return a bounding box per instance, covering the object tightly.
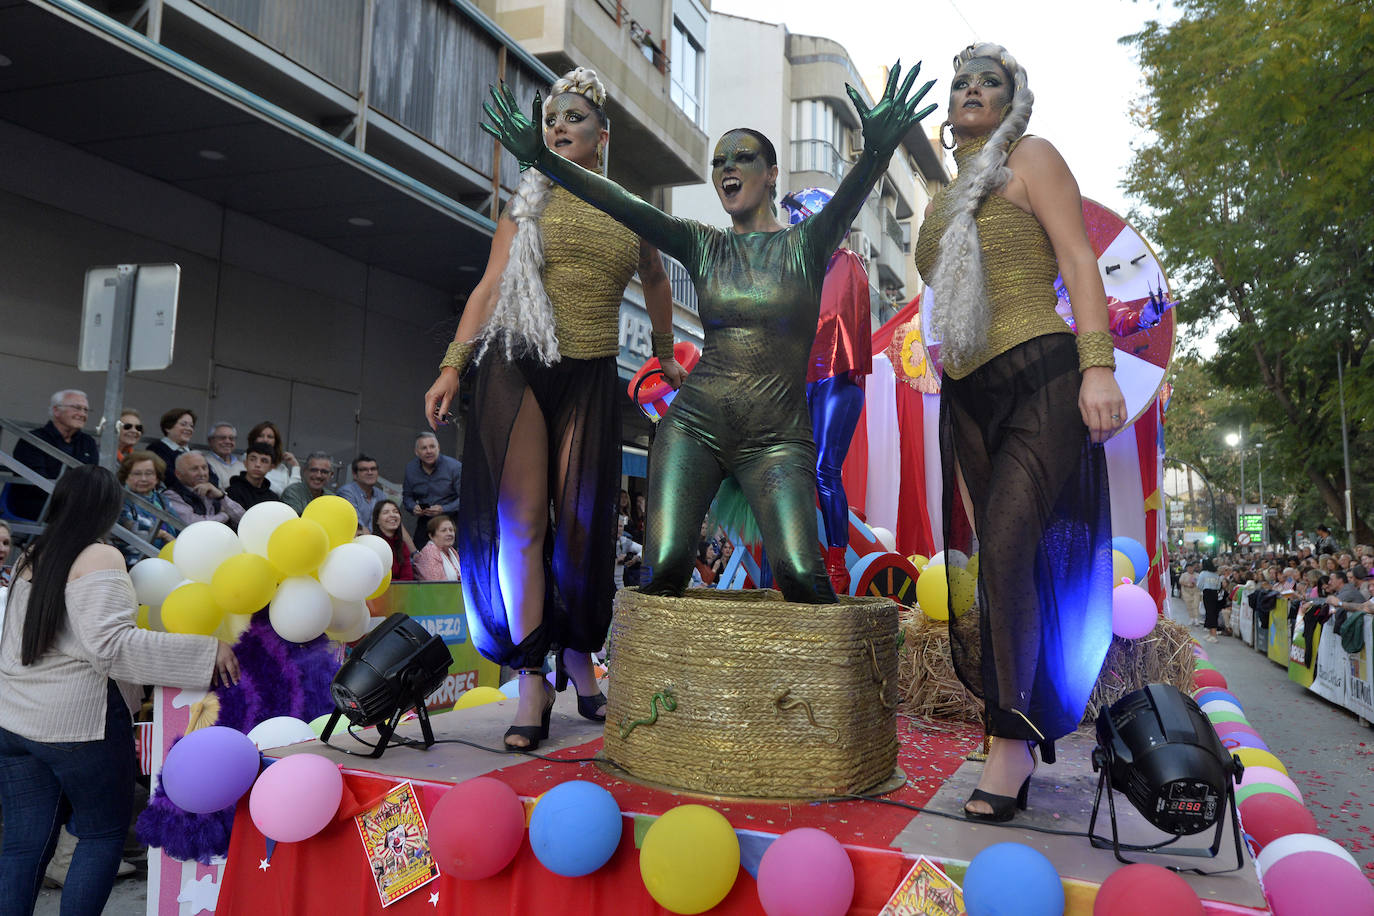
[425,67,684,751]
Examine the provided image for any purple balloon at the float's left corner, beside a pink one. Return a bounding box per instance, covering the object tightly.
[162,725,262,814]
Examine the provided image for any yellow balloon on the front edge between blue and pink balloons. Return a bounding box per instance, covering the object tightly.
[639,805,739,916]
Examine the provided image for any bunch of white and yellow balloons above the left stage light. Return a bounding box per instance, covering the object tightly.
[129,496,392,643]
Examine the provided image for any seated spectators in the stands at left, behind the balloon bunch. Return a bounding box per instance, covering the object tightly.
[0,389,478,585]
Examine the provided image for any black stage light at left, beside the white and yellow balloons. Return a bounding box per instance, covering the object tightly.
[320,612,453,757]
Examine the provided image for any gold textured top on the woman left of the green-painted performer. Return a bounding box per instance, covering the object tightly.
[539,184,639,360]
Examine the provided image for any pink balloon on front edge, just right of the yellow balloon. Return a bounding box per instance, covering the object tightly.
[758,827,855,916]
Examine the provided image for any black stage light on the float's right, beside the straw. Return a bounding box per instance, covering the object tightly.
[1088,684,1245,867]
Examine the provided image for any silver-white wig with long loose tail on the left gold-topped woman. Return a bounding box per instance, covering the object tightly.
[475,67,607,365]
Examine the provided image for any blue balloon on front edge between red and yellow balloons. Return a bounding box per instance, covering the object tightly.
[529,780,624,878]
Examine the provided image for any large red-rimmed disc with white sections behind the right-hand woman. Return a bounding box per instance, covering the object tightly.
[921,198,1176,428]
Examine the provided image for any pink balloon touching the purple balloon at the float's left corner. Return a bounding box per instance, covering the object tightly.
[249,754,344,843]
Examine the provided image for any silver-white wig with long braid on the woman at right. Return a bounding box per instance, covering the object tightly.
[930,43,1035,365]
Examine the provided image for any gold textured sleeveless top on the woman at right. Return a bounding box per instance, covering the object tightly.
[916,140,1073,379]
